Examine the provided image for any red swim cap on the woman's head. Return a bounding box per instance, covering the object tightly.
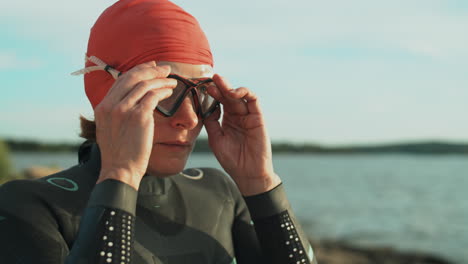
[84,0,213,108]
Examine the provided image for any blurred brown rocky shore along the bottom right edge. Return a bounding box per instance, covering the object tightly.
[312,241,455,264]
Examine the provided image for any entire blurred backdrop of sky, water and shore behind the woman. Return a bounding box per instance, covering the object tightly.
[0,0,468,263]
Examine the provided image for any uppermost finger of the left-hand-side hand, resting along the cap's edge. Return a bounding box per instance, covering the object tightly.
[104,61,171,105]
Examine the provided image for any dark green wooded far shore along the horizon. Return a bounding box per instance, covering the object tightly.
[5,138,468,155]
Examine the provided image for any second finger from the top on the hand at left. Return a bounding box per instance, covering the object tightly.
[119,78,177,110]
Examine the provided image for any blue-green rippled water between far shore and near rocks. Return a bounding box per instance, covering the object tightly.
[8,153,468,263]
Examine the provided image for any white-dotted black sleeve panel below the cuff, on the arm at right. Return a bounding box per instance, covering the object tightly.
[254,211,310,264]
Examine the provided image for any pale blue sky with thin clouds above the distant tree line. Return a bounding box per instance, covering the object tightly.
[0,0,468,145]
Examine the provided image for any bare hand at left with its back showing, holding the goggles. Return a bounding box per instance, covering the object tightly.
[94,61,177,190]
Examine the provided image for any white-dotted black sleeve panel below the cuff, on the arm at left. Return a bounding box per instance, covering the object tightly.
[97,209,135,264]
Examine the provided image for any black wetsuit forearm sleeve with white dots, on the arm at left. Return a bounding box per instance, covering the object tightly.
[65,180,137,264]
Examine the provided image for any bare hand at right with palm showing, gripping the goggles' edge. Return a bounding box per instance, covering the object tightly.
[204,74,281,196]
